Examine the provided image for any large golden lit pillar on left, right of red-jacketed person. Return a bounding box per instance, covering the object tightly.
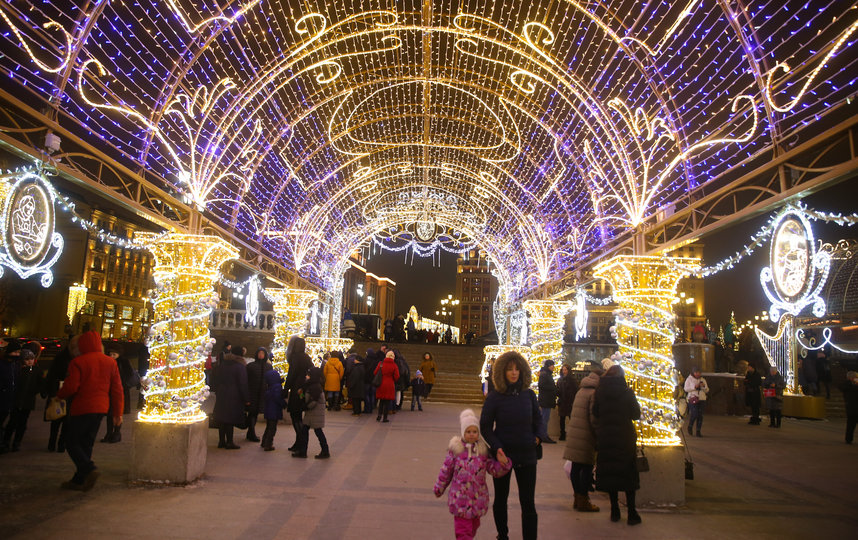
[136,233,238,424]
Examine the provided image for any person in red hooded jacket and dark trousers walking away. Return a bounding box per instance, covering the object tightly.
[57,332,123,491]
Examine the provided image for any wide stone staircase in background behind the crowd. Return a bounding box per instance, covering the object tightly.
[355,341,485,405]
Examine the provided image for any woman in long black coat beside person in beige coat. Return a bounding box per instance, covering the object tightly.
[593,365,641,525]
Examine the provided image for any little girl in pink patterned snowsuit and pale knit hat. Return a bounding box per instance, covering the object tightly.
[434,409,512,539]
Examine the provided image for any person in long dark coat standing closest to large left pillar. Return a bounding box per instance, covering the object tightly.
[213,347,250,450]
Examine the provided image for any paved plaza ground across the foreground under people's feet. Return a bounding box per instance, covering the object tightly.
[0,401,858,540]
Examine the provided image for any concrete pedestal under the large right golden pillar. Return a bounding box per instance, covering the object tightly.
[636,446,685,508]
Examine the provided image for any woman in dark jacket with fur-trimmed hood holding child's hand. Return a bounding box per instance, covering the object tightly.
[480,351,548,540]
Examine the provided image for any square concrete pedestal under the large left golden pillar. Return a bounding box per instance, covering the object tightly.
[130,421,208,484]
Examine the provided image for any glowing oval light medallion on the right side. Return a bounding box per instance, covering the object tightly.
[769,214,813,302]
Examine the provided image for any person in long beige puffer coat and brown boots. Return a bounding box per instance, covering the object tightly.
[563,363,603,512]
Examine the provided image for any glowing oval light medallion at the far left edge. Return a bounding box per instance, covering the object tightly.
[4,176,54,268]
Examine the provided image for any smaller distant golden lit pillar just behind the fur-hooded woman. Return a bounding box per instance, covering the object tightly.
[524,300,572,382]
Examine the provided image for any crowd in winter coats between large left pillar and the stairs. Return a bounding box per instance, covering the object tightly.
[206,342,437,459]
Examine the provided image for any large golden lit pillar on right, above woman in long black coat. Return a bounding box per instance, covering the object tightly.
[593,255,700,446]
